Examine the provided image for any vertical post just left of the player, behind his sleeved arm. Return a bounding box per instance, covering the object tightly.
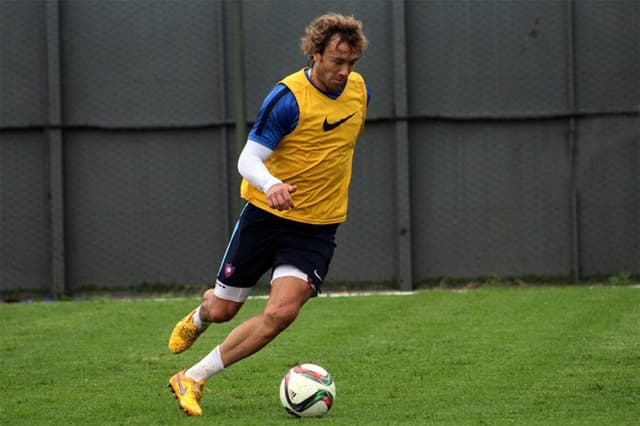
[229,0,247,223]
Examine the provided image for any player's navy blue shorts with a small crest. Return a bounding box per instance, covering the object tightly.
[217,204,338,292]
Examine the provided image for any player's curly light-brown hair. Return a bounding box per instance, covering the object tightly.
[300,12,369,62]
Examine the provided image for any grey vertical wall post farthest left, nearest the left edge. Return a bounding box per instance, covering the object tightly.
[45,0,66,297]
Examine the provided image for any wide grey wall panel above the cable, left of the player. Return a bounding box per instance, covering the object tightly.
[61,0,225,127]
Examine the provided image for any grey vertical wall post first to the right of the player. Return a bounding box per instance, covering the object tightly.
[392,1,413,291]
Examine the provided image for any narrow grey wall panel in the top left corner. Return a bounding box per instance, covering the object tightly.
[0,1,47,127]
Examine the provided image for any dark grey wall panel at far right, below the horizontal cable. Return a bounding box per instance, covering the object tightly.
[577,117,640,275]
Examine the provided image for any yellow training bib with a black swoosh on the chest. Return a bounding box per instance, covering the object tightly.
[241,69,367,225]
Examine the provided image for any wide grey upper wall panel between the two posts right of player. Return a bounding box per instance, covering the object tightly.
[407,0,567,117]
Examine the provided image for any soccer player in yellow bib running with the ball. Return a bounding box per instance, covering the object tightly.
[169,13,369,416]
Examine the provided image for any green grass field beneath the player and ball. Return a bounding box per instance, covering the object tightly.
[0,286,640,425]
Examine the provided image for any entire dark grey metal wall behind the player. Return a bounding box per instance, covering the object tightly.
[0,0,640,293]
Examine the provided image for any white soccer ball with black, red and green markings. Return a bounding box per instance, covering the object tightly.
[280,364,336,417]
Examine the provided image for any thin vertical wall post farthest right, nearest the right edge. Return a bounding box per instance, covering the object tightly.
[567,0,580,284]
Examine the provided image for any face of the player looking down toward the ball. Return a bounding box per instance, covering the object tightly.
[311,34,360,92]
